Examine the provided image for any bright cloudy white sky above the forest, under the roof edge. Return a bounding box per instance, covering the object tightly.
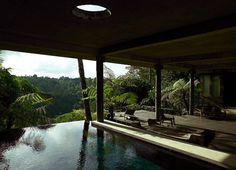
[0,51,128,78]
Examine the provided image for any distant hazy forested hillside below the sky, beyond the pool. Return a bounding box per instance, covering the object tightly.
[24,75,96,117]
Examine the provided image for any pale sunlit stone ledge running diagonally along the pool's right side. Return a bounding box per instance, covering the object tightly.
[92,120,236,169]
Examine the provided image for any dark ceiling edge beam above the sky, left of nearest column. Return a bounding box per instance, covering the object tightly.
[0,30,98,60]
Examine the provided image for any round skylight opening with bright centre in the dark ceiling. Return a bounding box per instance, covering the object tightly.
[72,0,111,20]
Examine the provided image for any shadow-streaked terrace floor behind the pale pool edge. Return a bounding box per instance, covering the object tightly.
[111,111,236,154]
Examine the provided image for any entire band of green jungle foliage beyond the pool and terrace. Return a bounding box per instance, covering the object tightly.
[0,49,195,127]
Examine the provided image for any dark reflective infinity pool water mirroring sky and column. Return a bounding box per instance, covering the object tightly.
[0,121,162,170]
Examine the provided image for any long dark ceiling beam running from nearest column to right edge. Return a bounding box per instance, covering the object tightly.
[99,13,236,55]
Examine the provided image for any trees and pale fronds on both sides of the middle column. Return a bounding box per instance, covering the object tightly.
[127,66,189,112]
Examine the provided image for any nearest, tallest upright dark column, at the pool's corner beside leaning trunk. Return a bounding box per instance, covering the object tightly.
[96,56,104,122]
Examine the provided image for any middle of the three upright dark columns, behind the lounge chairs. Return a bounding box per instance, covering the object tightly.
[155,64,163,120]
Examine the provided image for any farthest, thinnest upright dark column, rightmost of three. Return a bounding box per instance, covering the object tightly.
[189,70,195,115]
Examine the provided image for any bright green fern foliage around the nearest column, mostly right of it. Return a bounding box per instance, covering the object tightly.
[83,76,148,110]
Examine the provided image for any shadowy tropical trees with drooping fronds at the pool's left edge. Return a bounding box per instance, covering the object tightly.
[0,55,52,129]
